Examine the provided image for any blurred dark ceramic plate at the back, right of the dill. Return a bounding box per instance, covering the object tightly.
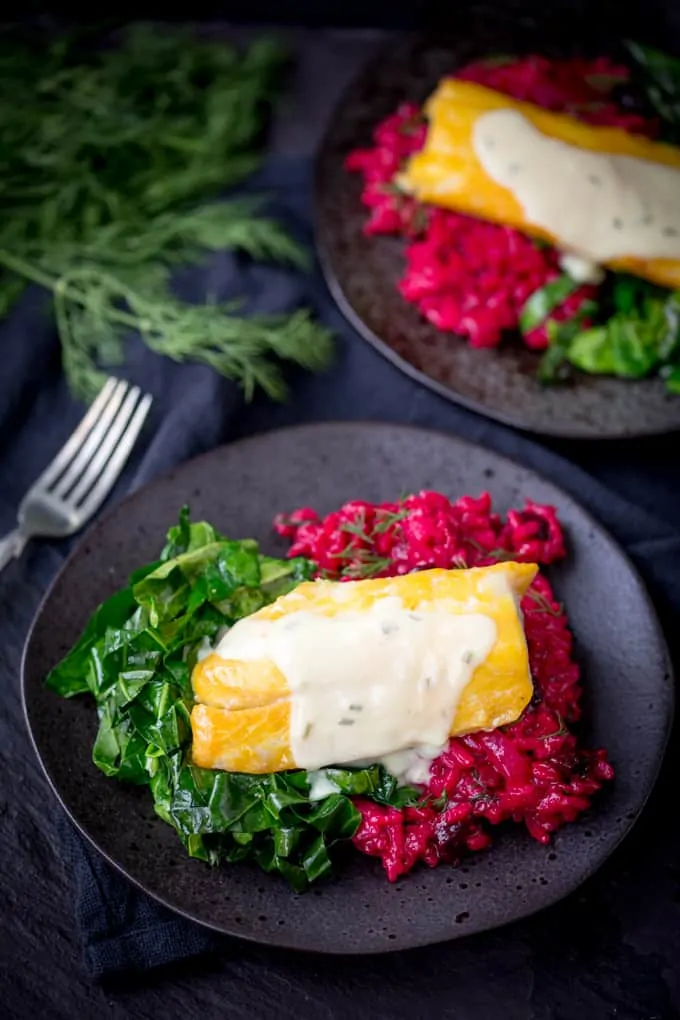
[316,17,680,439]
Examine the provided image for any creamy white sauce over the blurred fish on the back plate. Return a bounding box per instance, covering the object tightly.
[473,110,680,263]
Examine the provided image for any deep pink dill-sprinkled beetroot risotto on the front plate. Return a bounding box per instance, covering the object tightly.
[275,492,614,881]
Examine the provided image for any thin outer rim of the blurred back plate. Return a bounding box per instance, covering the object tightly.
[312,30,680,443]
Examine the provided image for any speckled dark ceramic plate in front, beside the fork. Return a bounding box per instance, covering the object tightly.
[23,424,673,953]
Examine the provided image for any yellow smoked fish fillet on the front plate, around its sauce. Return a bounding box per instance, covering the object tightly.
[191,563,537,773]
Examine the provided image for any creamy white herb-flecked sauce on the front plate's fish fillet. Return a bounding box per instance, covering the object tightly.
[217,593,496,781]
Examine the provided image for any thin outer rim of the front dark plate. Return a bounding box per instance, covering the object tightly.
[20,421,675,957]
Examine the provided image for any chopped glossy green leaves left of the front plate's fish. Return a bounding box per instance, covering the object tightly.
[46,509,409,890]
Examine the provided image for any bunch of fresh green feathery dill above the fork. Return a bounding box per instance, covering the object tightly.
[0,27,331,399]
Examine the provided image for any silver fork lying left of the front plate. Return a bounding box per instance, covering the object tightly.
[0,378,151,570]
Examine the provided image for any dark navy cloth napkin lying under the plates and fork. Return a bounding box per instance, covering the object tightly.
[0,158,680,977]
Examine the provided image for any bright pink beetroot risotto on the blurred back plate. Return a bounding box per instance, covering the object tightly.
[346,56,657,350]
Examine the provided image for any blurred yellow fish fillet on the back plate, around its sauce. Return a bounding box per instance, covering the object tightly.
[399,79,680,288]
